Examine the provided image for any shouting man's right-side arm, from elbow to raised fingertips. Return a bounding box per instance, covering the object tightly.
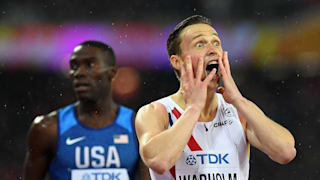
[219,52,296,164]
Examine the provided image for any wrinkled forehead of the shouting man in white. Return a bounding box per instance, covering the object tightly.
[180,24,219,42]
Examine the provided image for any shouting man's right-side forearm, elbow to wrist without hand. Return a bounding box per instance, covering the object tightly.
[234,98,296,164]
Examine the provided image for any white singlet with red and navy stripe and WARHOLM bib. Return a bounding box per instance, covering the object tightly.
[149,93,249,180]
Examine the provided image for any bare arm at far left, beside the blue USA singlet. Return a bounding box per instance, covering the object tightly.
[23,112,58,180]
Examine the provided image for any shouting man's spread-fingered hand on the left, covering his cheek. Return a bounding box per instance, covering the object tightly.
[181,56,217,110]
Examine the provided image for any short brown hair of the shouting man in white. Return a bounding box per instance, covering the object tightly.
[167,15,212,78]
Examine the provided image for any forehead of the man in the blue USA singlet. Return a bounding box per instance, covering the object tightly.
[71,45,103,59]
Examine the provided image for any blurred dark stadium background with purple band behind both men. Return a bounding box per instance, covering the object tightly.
[0,0,320,180]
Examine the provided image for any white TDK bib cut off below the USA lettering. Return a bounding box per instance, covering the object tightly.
[71,168,129,180]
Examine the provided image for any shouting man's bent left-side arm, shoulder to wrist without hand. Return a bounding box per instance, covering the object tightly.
[136,103,200,174]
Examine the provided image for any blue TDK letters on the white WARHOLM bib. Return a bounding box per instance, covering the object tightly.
[196,153,229,164]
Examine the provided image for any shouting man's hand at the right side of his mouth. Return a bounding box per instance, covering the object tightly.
[218,51,243,105]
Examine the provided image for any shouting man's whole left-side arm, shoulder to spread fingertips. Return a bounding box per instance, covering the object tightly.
[136,57,215,174]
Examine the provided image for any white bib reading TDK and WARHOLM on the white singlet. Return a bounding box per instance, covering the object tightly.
[175,150,240,180]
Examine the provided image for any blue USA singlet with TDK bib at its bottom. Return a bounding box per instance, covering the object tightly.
[50,104,139,180]
